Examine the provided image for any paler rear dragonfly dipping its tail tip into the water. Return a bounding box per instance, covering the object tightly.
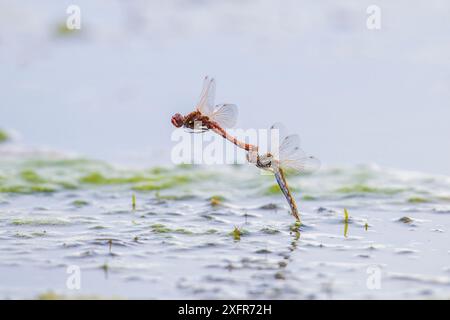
[253,124,320,222]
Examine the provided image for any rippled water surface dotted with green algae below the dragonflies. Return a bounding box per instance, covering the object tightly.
[0,147,450,299]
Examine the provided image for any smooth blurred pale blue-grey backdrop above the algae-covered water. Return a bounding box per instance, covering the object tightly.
[0,0,450,174]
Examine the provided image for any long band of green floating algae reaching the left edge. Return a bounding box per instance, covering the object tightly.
[0,158,200,195]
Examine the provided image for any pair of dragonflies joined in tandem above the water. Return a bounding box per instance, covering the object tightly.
[172,77,320,221]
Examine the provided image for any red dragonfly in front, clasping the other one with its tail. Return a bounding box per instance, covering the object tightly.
[171,76,258,152]
